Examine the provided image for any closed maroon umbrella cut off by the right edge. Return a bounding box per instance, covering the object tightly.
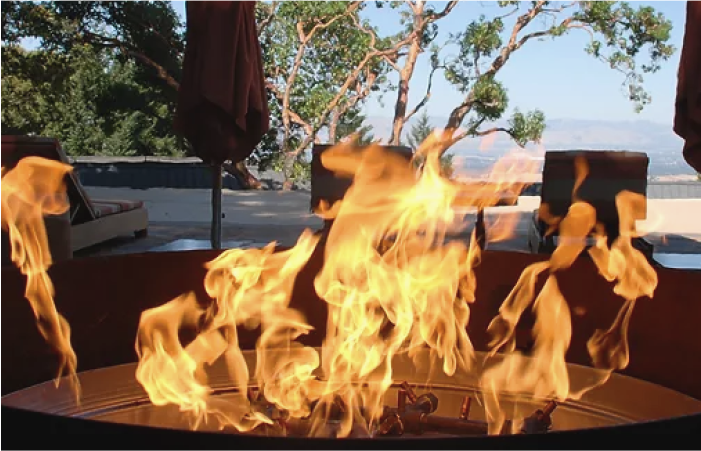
[674,0,701,172]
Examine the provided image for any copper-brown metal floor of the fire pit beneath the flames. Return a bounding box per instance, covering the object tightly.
[2,351,701,443]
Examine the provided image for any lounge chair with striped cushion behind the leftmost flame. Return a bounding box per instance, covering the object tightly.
[2,135,148,252]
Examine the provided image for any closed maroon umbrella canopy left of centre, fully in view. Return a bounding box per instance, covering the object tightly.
[174,0,270,164]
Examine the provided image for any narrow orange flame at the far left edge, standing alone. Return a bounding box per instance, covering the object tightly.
[1,157,79,394]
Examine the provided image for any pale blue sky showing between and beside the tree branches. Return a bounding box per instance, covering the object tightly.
[172,0,686,124]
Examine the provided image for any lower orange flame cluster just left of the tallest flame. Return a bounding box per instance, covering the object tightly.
[136,231,319,431]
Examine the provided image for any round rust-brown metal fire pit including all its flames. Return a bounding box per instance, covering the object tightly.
[1,147,701,449]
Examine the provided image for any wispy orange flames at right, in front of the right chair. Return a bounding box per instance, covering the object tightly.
[481,159,657,433]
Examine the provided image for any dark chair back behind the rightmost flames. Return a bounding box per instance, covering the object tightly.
[528,150,652,255]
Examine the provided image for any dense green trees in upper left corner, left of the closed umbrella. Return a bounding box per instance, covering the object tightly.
[2,0,188,156]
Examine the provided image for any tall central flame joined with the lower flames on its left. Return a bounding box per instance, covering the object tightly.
[137,133,540,436]
